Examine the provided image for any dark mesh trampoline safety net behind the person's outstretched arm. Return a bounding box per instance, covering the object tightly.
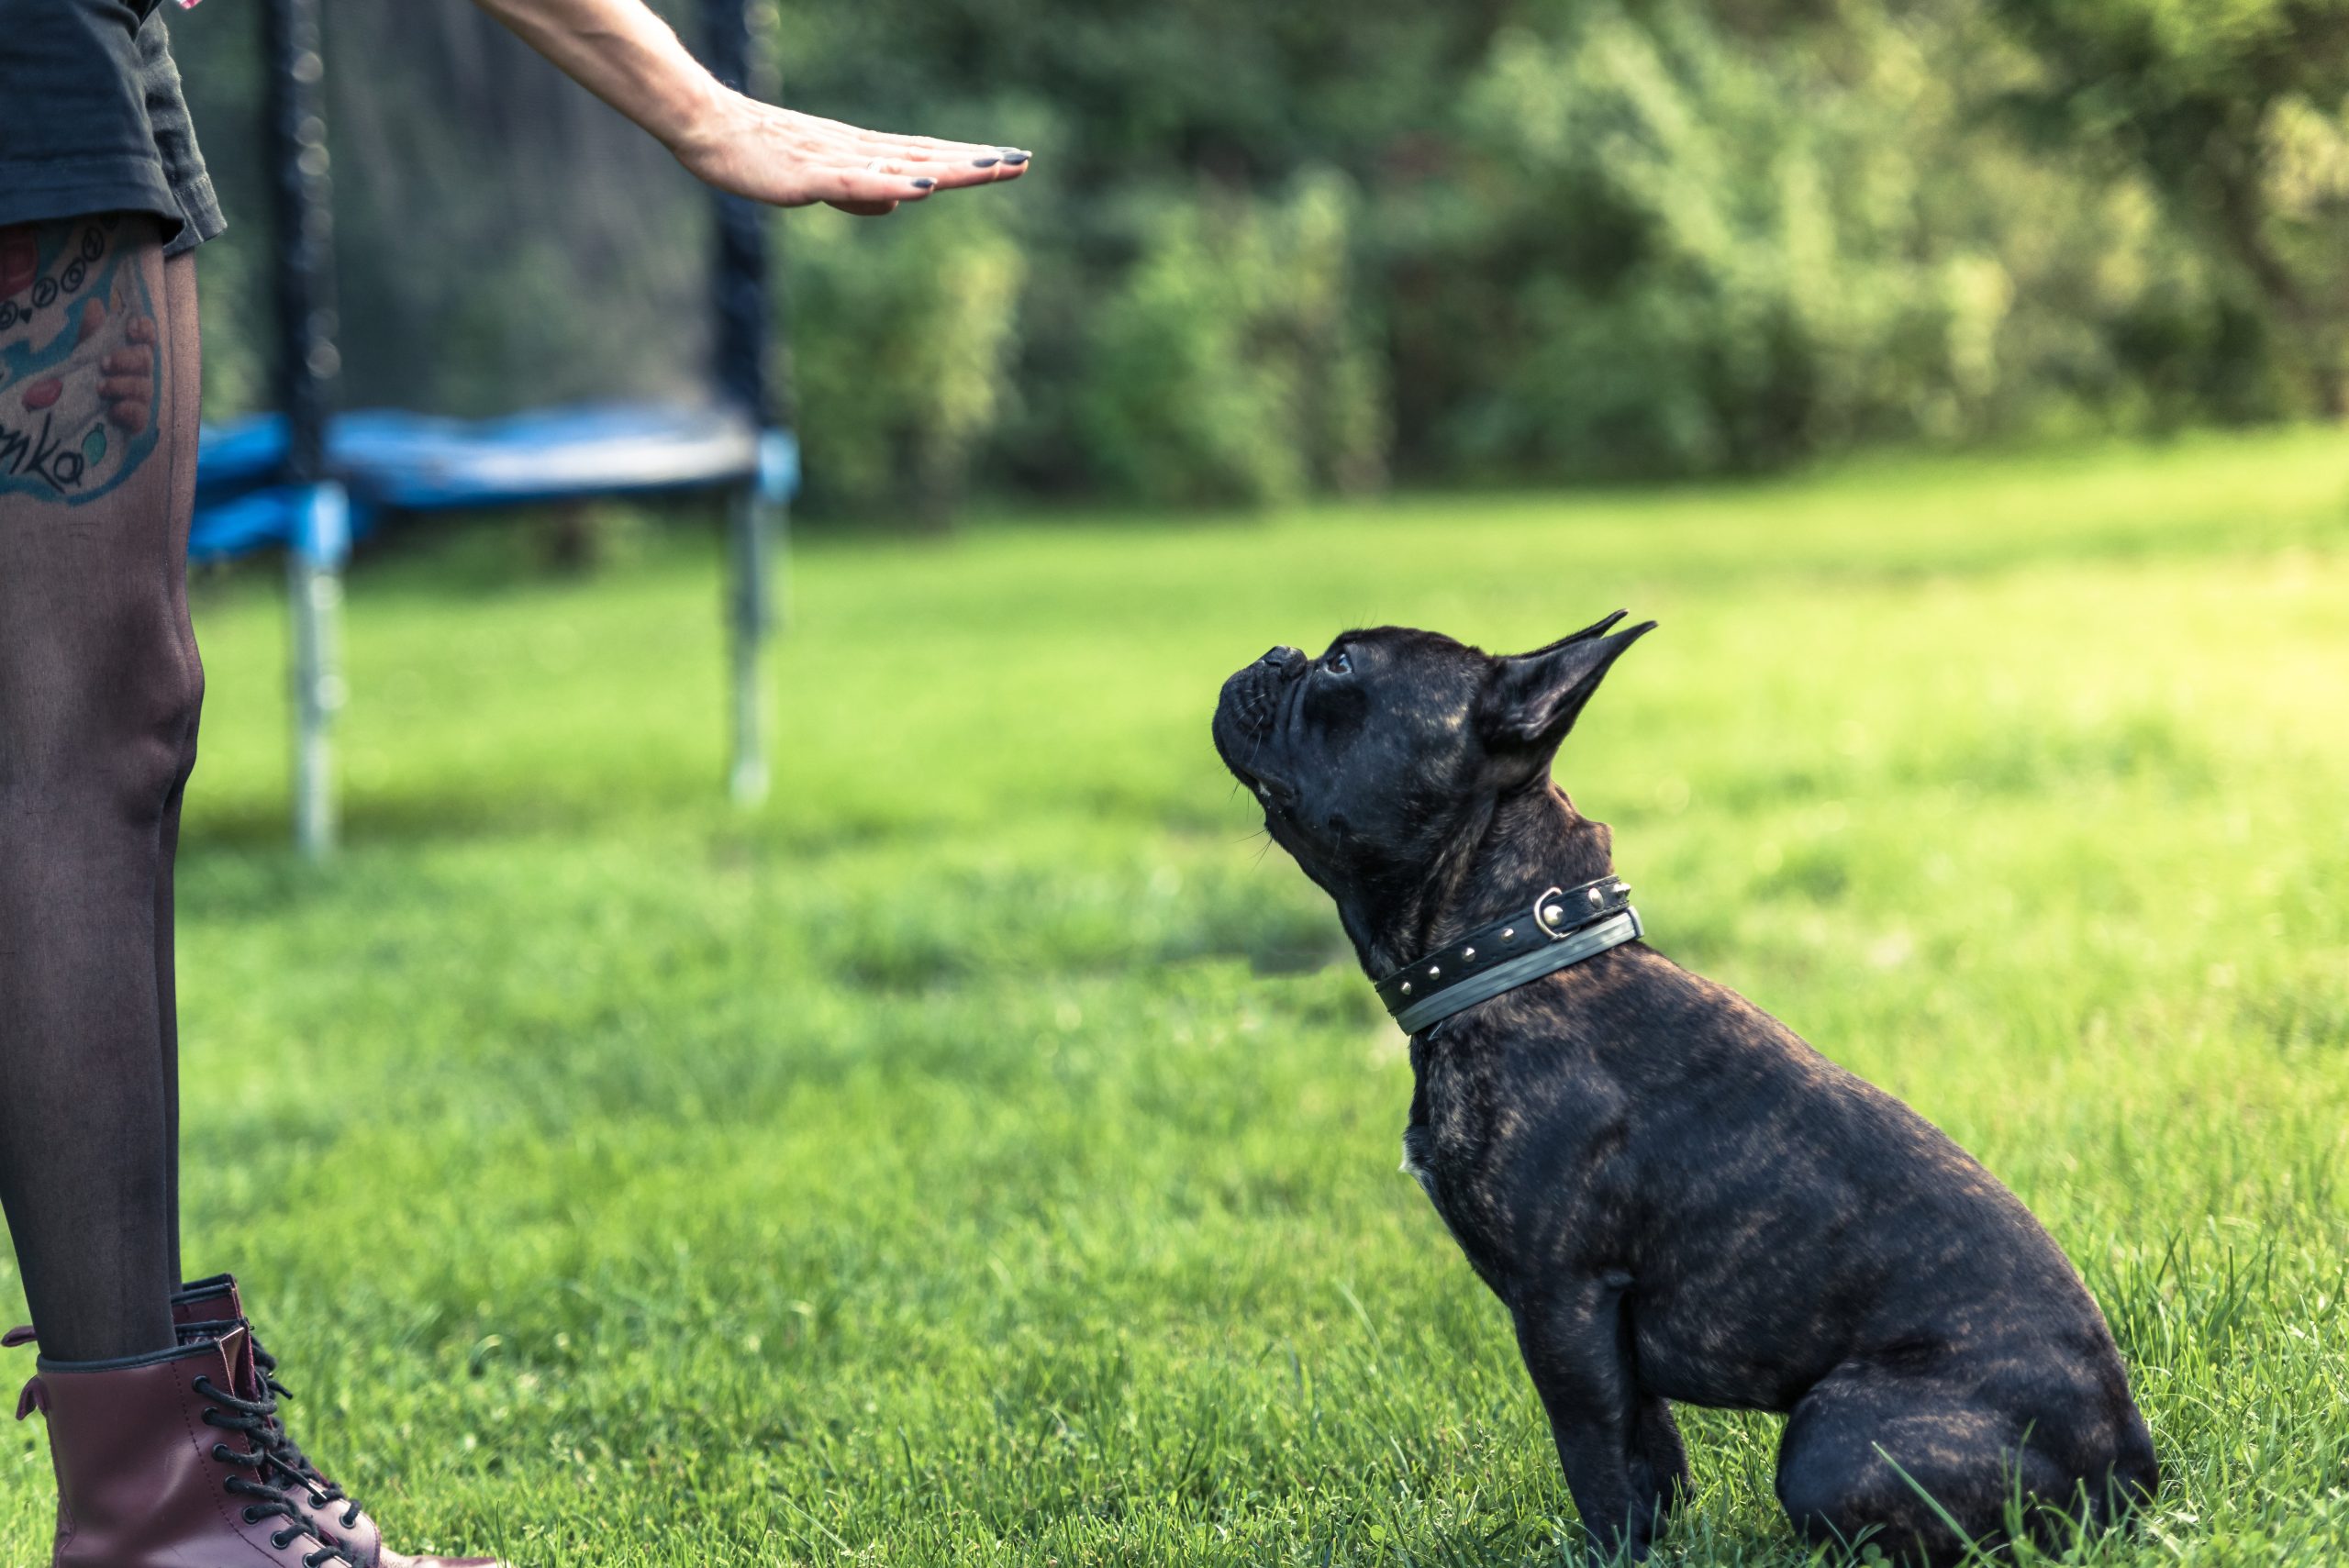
[172,0,768,417]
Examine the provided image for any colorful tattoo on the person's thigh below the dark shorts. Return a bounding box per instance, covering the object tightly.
[0,218,160,502]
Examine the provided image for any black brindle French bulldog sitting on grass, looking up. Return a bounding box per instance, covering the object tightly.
[1215,613,2156,1563]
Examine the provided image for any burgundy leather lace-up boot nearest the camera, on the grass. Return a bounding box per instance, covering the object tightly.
[17,1329,360,1568]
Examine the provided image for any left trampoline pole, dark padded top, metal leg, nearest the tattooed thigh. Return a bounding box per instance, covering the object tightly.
[261,0,350,859]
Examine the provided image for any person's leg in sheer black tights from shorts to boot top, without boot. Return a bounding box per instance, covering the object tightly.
[0,216,202,1362]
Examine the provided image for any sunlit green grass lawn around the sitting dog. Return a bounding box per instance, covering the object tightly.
[0,432,2349,1568]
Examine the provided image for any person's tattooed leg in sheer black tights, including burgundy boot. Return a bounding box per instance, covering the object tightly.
[0,218,498,1568]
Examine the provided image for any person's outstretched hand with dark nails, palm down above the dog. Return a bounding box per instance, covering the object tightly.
[672,94,1029,216]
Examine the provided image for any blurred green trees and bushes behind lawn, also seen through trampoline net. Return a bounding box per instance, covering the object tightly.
[173,0,2349,521]
